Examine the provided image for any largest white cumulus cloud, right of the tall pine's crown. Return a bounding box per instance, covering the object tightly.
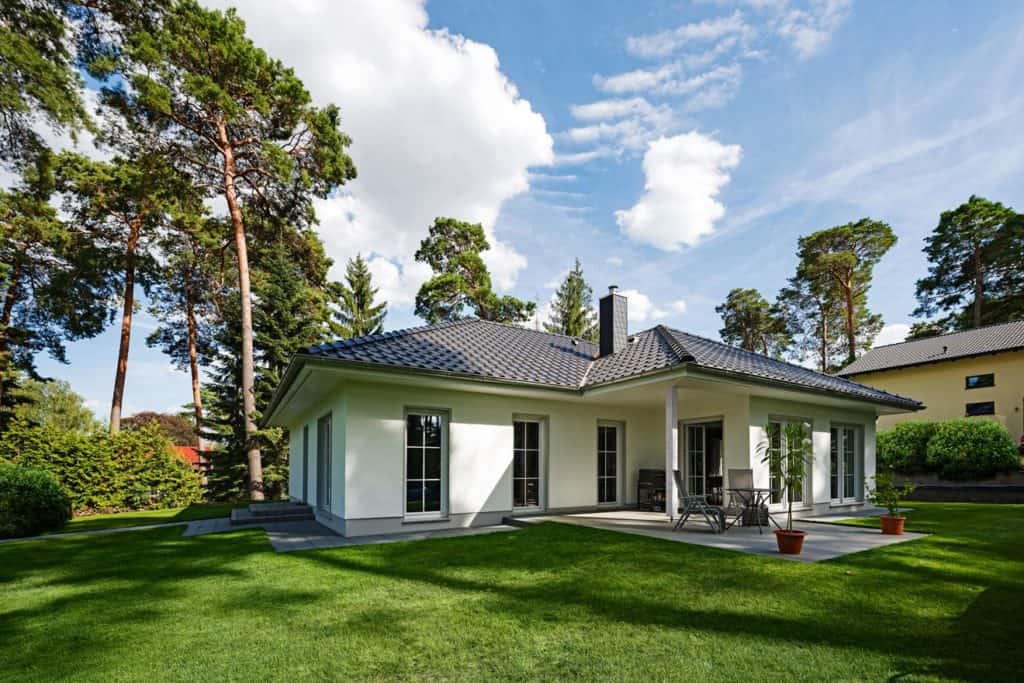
[205,0,554,305]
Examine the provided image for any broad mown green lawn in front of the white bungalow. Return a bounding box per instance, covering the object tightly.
[0,503,1024,681]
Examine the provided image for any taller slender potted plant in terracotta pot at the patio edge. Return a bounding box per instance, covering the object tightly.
[762,422,813,555]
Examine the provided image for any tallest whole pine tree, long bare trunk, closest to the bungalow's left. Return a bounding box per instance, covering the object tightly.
[103,0,355,500]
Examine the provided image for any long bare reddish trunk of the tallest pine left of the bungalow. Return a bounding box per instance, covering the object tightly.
[220,125,263,501]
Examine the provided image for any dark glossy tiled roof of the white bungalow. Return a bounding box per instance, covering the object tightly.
[299,318,920,409]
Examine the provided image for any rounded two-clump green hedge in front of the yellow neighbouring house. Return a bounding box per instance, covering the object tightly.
[877,419,1020,479]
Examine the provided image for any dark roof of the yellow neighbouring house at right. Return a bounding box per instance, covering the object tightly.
[839,321,1024,375]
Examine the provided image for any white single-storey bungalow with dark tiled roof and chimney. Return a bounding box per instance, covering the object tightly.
[264,288,921,536]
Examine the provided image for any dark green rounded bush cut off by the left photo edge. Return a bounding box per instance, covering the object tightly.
[0,462,71,538]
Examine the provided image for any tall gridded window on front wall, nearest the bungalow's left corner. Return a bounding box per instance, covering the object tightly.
[406,412,446,515]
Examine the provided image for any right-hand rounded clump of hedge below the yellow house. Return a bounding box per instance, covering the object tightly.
[927,420,1020,479]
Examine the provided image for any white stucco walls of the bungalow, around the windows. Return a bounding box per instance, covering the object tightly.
[289,381,874,535]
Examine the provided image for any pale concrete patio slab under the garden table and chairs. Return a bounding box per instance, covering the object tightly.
[517,510,927,562]
